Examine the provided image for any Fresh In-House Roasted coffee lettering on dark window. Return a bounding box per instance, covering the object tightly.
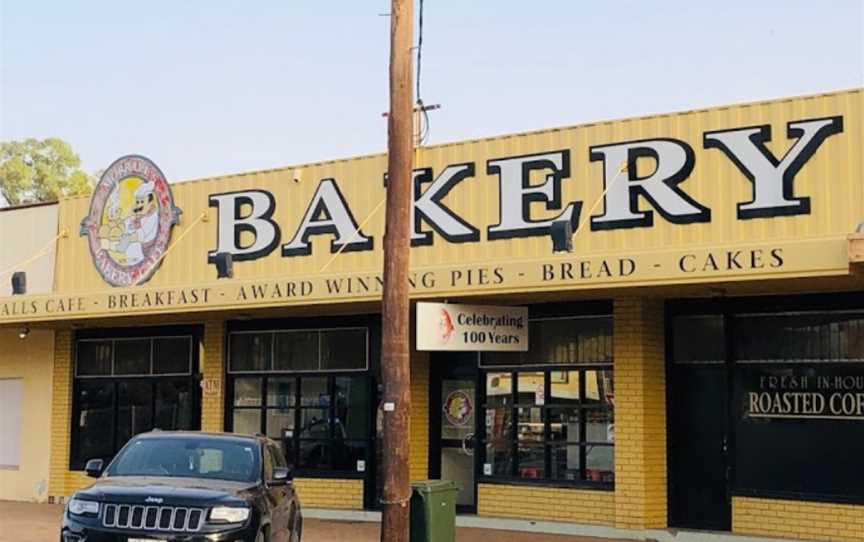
[745,375,864,420]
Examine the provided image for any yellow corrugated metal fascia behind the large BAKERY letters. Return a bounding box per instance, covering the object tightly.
[50,90,864,300]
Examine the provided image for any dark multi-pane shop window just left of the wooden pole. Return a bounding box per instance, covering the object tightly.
[228,328,374,474]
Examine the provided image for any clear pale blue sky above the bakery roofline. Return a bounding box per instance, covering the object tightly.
[0,0,864,184]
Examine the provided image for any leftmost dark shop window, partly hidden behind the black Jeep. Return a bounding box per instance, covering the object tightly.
[70,335,199,470]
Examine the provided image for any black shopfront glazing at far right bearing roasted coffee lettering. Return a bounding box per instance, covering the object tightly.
[669,306,864,514]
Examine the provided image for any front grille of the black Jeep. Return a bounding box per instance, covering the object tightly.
[102,504,204,533]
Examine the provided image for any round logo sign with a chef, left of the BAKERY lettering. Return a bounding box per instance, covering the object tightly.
[81,155,180,286]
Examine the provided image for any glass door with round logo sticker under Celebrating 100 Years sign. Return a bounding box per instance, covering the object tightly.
[430,354,477,513]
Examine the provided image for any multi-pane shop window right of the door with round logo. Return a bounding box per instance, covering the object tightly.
[480,316,615,488]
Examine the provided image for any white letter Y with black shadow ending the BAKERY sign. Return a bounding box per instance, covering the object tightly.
[703,117,843,220]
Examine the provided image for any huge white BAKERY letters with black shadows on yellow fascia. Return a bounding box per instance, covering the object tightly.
[209,116,843,262]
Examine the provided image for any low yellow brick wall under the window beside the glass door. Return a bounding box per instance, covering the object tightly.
[477,484,615,526]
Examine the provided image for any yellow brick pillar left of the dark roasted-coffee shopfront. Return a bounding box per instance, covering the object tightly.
[614,298,667,529]
